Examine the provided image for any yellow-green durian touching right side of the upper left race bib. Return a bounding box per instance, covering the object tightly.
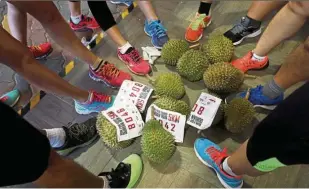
[153,72,186,99]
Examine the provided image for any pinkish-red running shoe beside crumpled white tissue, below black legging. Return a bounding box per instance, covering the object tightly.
[117,47,151,75]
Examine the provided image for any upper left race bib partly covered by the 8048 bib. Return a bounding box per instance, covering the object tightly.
[114,80,153,113]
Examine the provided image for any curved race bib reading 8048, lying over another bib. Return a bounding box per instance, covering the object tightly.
[102,101,144,142]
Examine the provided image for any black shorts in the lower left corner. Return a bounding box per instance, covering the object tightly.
[0,102,51,187]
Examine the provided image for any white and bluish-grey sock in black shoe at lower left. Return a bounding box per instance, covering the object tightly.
[44,128,66,148]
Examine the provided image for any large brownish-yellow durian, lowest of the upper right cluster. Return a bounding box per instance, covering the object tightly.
[204,62,245,93]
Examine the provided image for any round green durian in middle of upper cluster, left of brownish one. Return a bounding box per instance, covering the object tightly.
[177,49,209,82]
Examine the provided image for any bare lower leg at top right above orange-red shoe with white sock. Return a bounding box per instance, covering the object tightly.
[253,1,309,56]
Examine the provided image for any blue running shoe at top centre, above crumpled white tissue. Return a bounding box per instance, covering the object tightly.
[144,20,168,49]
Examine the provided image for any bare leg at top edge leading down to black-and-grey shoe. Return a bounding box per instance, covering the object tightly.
[247,1,287,21]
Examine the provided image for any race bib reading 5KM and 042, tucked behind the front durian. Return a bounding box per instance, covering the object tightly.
[146,104,186,143]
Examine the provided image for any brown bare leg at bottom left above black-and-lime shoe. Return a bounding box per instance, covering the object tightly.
[34,150,104,188]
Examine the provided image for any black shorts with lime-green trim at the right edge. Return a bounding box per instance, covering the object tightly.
[247,83,309,169]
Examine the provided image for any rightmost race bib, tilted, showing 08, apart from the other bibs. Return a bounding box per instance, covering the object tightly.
[187,93,222,129]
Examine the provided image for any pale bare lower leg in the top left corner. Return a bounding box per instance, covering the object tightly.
[7,3,27,46]
